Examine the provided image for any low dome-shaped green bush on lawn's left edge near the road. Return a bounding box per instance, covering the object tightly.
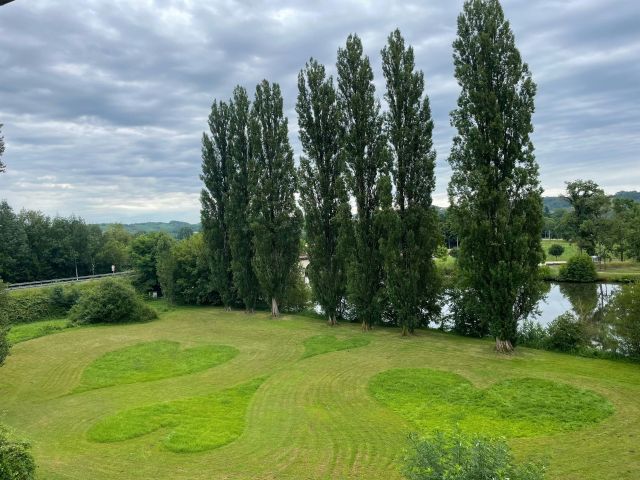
[69,279,158,324]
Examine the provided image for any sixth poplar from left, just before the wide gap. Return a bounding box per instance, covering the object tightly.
[382,30,439,335]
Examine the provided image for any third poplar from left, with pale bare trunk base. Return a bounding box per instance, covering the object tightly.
[250,80,302,317]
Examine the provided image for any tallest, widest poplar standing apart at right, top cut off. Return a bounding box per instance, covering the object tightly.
[449,0,543,352]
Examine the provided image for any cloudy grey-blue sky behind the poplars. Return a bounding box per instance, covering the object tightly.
[0,0,640,223]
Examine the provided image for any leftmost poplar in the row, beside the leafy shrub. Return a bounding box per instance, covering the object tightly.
[200,101,234,309]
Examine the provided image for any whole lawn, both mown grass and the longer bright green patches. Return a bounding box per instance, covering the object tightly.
[0,308,640,480]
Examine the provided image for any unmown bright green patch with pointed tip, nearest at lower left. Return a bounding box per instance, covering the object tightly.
[87,378,264,453]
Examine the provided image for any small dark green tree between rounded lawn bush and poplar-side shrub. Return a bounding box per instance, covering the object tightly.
[130,232,174,293]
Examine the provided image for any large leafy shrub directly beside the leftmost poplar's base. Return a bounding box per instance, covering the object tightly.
[157,233,219,305]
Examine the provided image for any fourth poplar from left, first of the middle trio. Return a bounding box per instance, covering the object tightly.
[296,59,351,325]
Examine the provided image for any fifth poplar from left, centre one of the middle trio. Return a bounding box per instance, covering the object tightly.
[337,35,387,330]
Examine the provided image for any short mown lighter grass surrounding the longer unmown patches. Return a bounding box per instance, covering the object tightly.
[0,308,640,480]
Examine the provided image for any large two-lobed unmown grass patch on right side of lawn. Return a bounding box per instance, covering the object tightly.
[369,368,613,437]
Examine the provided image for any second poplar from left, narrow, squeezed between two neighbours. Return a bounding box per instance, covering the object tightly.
[226,86,260,312]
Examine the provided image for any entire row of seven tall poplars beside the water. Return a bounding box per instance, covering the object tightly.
[202,0,542,350]
